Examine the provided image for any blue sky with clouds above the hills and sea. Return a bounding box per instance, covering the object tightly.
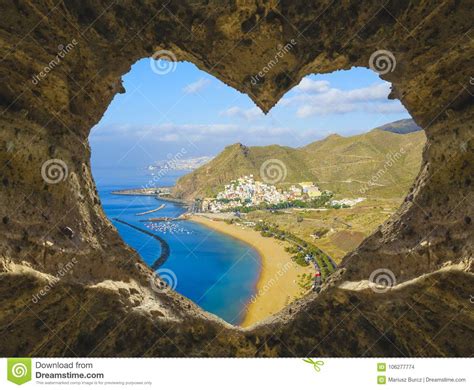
[89,59,409,167]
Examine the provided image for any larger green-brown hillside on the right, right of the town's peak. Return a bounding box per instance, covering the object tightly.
[301,130,426,198]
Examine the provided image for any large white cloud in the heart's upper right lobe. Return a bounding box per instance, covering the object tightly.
[282,78,405,118]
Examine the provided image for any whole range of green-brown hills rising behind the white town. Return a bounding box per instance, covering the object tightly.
[174,125,426,199]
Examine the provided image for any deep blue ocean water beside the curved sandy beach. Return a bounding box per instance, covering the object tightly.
[93,168,260,324]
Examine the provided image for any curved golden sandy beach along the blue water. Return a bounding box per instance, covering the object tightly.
[189,215,311,327]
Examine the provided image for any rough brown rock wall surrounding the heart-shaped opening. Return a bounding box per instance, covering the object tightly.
[0,0,474,356]
